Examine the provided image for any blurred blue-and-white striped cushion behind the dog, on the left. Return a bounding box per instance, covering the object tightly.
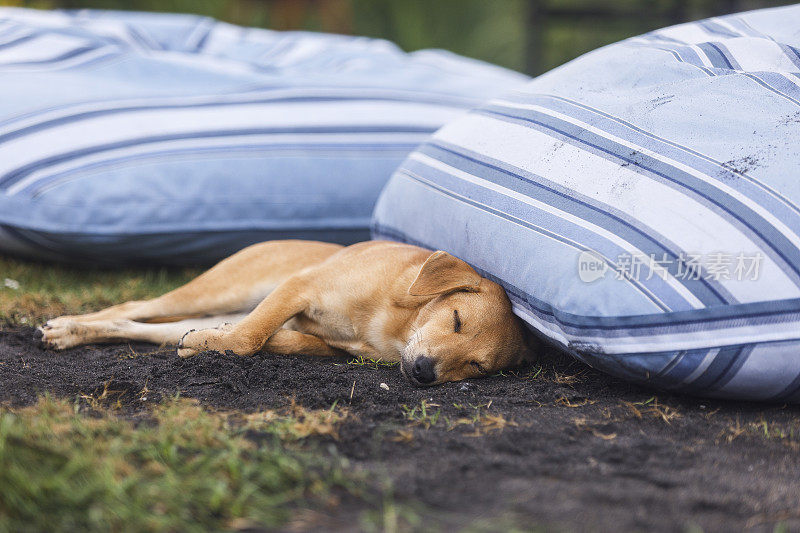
[0,8,528,262]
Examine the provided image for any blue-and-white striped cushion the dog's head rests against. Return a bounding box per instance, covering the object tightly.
[373,6,800,402]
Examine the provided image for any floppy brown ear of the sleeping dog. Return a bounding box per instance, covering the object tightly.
[408,250,481,296]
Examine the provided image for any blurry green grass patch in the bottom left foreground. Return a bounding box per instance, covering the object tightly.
[0,392,368,532]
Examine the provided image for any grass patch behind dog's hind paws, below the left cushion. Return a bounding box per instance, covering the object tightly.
[0,256,201,325]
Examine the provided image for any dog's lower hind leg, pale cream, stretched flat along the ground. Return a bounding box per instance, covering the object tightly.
[41,314,246,350]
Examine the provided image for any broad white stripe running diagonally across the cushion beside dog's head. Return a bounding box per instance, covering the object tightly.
[434,114,800,302]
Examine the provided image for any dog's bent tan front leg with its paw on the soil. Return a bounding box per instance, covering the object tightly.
[178,274,313,357]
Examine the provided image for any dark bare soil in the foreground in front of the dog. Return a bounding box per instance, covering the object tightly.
[0,328,800,531]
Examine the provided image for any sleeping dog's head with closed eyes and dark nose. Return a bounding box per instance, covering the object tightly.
[400,251,530,385]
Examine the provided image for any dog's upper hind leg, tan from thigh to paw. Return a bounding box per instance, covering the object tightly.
[42,241,342,330]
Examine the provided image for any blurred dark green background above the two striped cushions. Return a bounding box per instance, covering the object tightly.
[0,0,792,74]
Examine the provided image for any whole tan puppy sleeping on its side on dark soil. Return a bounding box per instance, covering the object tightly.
[39,241,529,385]
